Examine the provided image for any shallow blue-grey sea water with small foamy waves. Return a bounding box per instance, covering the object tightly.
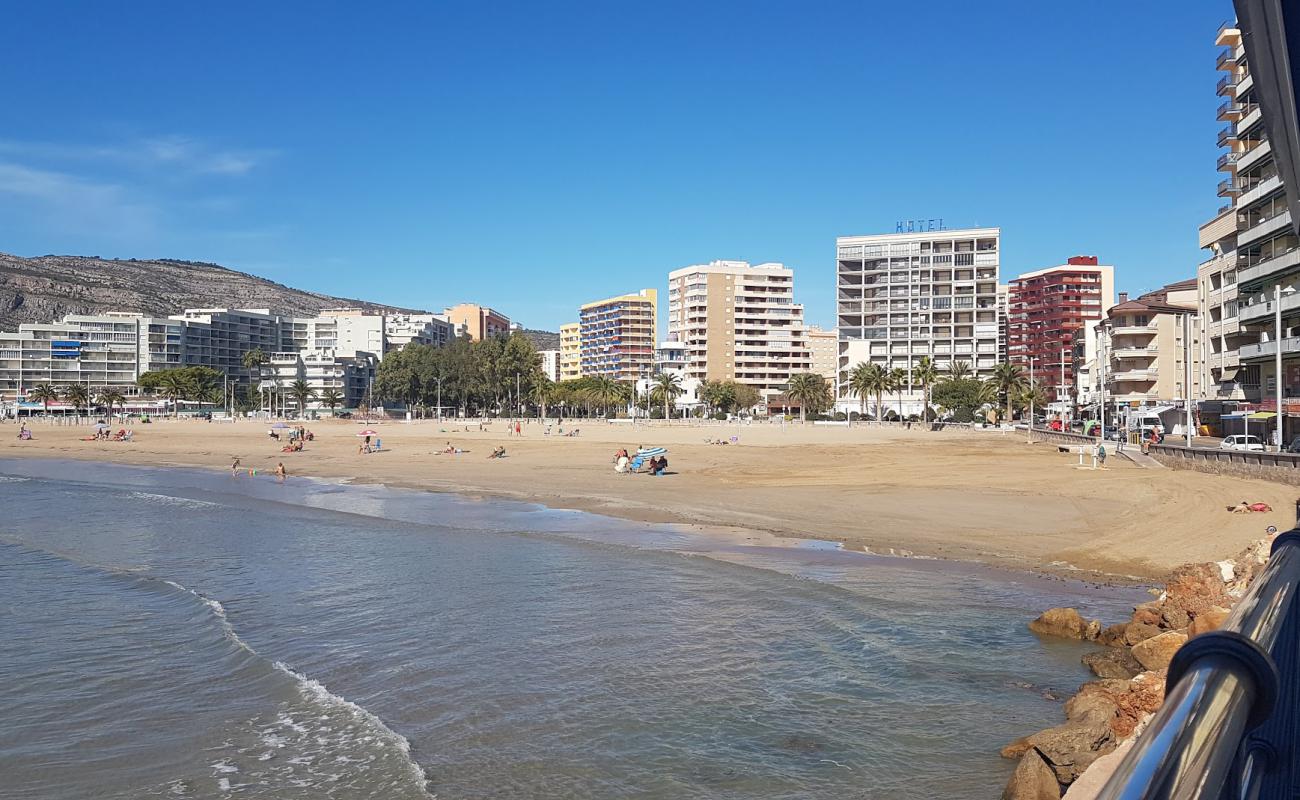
[0,460,1139,800]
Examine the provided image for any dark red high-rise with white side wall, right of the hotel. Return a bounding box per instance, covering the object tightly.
[1006,255,1115,410]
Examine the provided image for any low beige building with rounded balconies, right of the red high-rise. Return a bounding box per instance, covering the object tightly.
[1099,278,1201,416]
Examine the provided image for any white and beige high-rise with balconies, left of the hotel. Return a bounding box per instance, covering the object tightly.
[668,261,813,398]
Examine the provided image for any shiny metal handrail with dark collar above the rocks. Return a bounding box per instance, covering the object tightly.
[1097,527,1300,800]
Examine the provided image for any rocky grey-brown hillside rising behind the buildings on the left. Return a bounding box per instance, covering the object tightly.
[0,252,421,330]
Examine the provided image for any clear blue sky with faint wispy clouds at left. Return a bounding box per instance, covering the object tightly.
[0,0,1232,330]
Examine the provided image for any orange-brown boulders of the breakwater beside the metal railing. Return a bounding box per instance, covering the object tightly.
[1002,540,1271,800]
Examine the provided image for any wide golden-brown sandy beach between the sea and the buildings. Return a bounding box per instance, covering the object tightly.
[10,420,1295,579]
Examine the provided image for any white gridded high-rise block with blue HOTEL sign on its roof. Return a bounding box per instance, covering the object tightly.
[836,228,1001,415]
